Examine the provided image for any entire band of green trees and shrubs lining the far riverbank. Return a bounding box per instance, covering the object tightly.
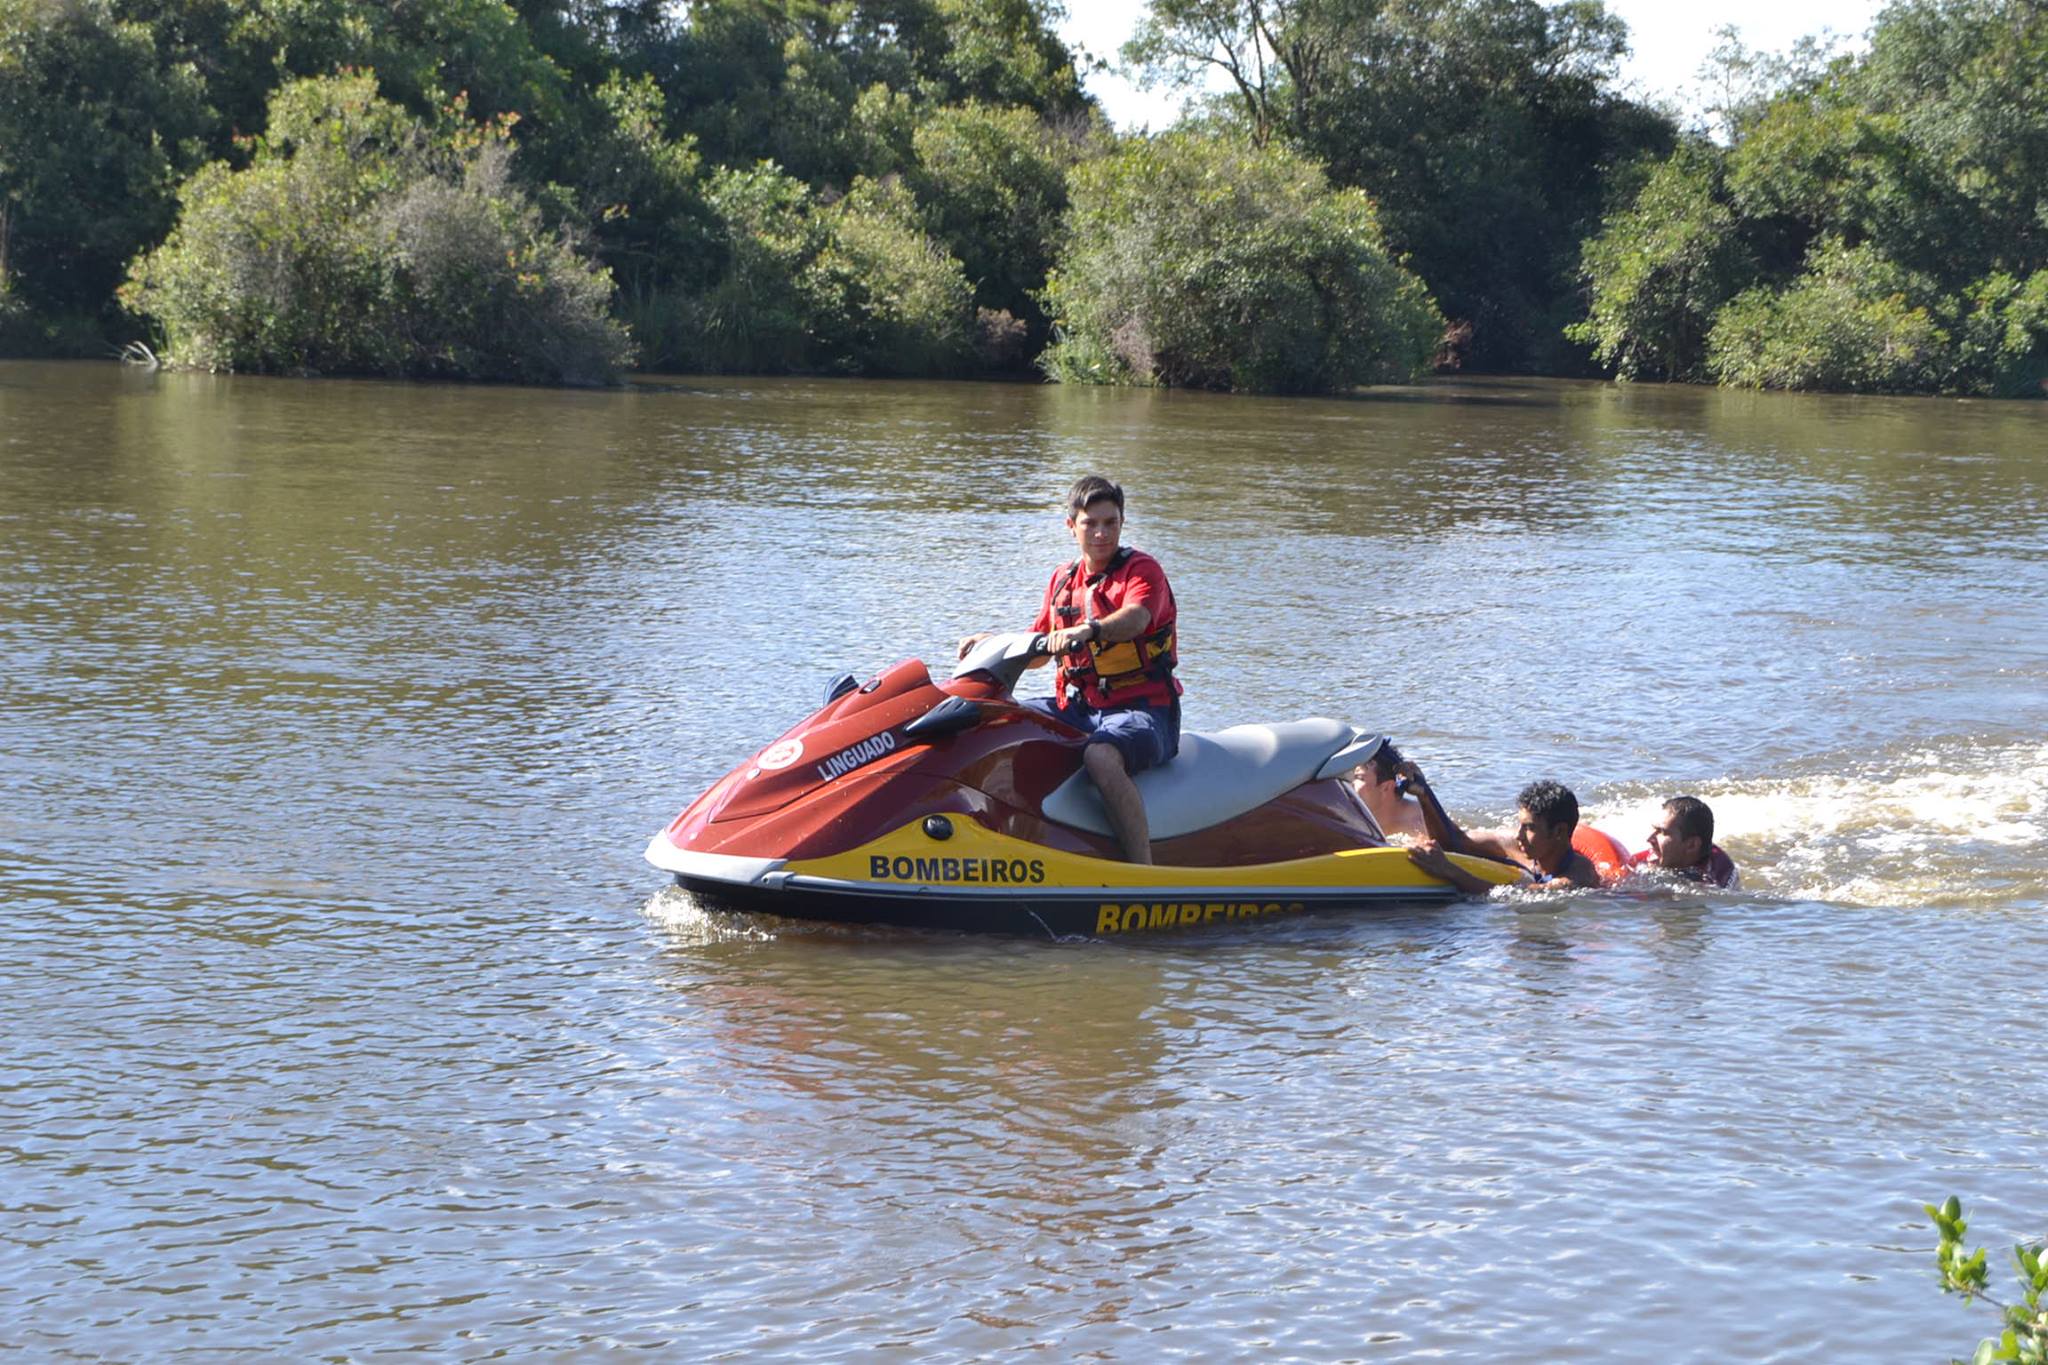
[0,0,2048,395]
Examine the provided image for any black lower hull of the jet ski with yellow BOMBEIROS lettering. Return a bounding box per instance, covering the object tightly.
[676,874,1456,939]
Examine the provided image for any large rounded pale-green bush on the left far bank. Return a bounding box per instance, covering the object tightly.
[125,74,631,383]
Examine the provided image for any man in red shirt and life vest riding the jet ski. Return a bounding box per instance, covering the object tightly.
[961,475,1182,864]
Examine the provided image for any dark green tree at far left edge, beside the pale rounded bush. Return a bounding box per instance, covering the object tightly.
[0,0,209,348]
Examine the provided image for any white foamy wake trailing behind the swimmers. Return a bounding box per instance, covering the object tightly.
[1585,741,2048,905]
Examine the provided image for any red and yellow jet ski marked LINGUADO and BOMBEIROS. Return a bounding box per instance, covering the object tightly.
[647,634,1520,937]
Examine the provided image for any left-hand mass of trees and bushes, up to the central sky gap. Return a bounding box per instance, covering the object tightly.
[0,0,1092,377]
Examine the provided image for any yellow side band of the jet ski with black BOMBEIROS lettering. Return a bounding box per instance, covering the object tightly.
[782,817,1522,909]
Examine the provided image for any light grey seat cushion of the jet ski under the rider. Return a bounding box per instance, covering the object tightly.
[1044,716,1386,839]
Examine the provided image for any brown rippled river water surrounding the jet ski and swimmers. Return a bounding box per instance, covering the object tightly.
[0,362,2048,1363]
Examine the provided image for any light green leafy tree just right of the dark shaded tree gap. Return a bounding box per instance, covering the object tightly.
[1569,147,1755,379]
